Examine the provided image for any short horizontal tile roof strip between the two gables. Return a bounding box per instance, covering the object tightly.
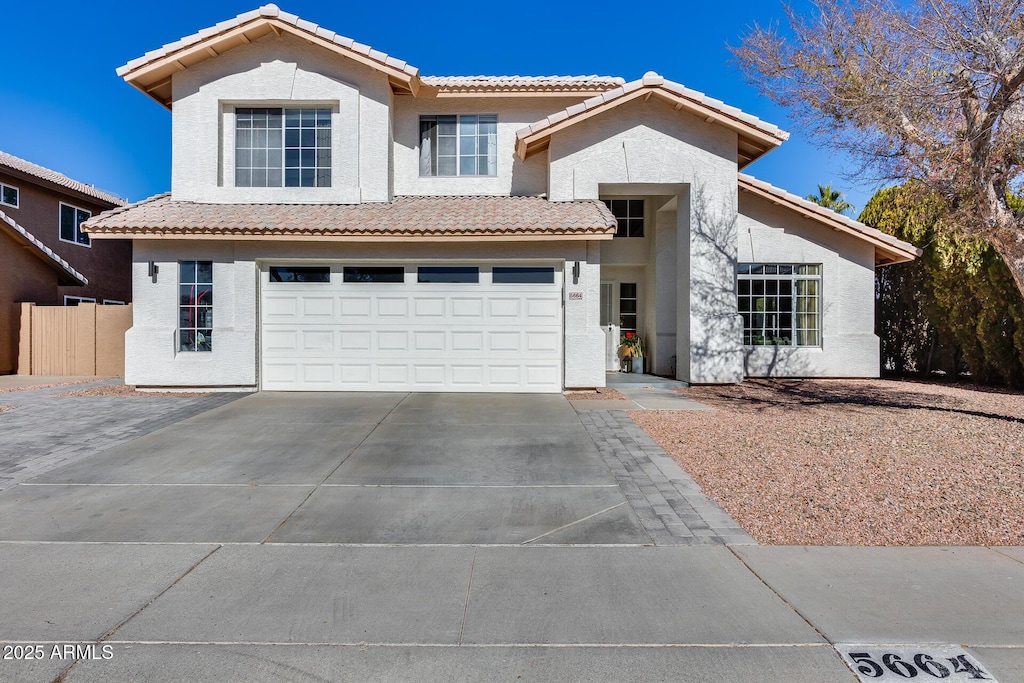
[420,76,626,97]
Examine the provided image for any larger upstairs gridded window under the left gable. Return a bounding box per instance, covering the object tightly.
[234,108,331,187]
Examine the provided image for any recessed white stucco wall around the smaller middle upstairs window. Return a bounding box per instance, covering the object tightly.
[394,96,583,196]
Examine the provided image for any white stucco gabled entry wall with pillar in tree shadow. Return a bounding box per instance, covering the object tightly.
[548,98,742,383]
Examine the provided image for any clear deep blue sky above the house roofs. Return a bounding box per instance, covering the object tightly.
[0,0,874,210]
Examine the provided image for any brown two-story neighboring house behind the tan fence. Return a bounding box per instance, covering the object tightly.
[0,152,131,375]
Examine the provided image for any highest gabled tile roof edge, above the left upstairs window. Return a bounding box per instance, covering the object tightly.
[118,4,420,109]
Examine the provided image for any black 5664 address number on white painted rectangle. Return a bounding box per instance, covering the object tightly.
[836,645,997,683]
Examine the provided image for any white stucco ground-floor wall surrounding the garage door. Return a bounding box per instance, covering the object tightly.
[125,240,604,388]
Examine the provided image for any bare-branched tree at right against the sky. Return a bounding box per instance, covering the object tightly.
[733,0,1024,296]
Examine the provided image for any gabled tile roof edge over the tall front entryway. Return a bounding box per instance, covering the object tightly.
[516,72,790,168]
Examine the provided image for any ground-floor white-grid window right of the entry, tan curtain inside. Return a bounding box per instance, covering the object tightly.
[736,263,821,346]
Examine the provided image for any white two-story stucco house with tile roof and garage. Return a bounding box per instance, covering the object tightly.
[85,5,919,391]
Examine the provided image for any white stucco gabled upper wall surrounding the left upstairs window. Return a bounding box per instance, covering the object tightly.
[171,34,392,204]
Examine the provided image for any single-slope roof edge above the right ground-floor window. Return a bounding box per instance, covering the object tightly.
[739,173,924,265]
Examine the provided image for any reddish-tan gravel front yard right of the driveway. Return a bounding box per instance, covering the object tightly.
[630,380,1024,546]
